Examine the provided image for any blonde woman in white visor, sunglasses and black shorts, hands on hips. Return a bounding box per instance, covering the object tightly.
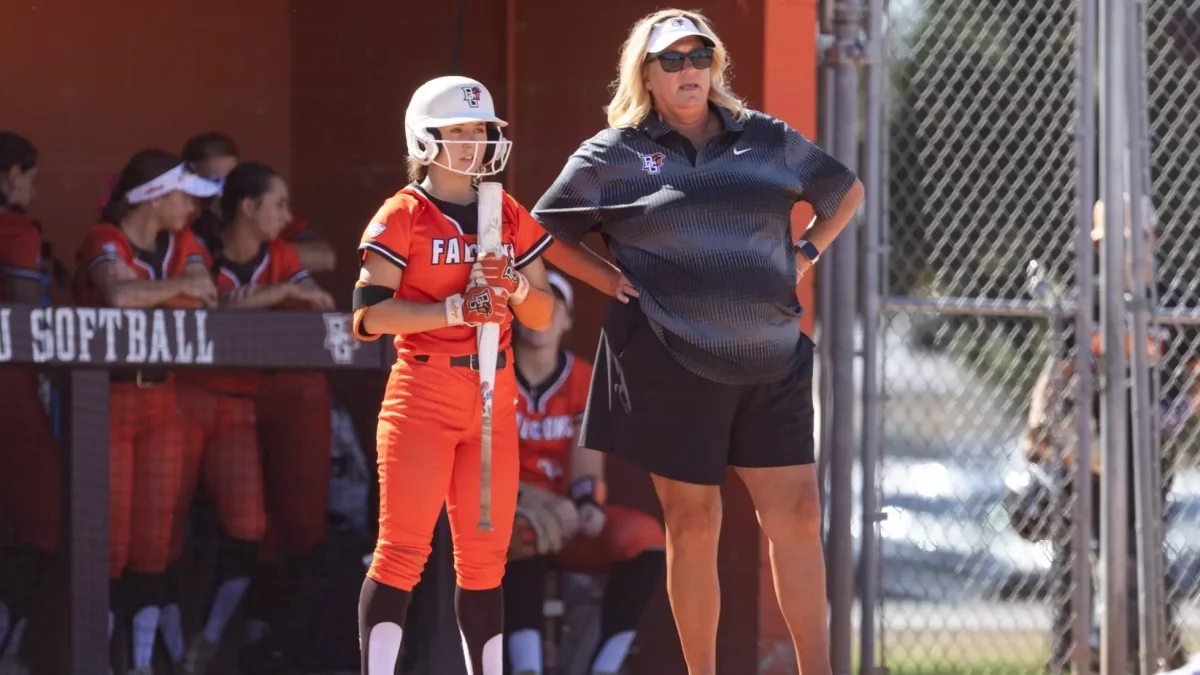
[533,10,863,675]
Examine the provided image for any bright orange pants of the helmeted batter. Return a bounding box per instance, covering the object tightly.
[367,353,520,591]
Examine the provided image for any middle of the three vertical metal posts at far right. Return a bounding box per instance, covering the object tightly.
[1100,0,1129,674]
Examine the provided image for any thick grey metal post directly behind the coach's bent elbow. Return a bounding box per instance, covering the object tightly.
[827,0,862,675]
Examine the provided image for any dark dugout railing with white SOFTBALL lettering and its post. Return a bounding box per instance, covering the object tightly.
[0,304,400,675]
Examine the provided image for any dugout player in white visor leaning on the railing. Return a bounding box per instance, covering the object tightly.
[76,150,220,674]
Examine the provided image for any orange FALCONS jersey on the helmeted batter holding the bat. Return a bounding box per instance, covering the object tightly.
[359,186,552,357]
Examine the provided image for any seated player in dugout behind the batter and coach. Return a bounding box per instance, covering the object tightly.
[504,271,666,675]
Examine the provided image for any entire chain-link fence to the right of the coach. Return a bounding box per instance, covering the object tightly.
[858,0,1200,673]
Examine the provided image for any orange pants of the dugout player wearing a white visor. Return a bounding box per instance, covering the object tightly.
[108,380,184,579]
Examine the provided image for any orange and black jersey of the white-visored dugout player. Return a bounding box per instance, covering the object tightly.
[76,222,206,306]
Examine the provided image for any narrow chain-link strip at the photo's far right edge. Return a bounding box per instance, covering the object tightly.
[1142,0,1200,652]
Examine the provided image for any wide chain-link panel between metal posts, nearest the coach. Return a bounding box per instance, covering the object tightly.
[864,0,1092,673]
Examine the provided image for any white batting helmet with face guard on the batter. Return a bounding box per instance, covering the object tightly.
[404,76,512,175]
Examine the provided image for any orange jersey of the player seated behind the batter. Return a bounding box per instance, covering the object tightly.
[517,352,592,495]
